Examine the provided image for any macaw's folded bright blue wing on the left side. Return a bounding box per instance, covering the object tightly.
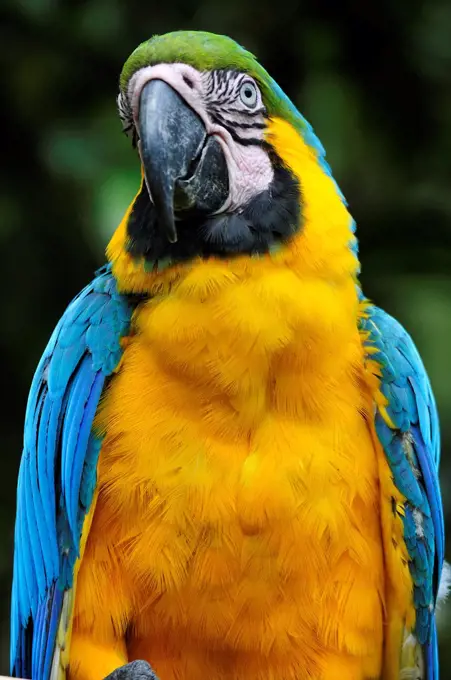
[11,268,132,680]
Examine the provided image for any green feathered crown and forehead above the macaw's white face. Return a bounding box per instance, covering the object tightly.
[120,31,306,133]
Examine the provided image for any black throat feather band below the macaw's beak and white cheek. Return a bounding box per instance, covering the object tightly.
[127,152,302,270]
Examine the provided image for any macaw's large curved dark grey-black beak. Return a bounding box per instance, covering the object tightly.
[139,80,229,243]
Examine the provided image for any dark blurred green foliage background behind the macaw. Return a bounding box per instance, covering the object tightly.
[0,0,451,678]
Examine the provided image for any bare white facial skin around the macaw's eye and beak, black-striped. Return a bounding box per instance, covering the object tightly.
[123,63,274,213]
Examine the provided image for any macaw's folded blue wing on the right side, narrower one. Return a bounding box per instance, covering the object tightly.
[361,307,444,680]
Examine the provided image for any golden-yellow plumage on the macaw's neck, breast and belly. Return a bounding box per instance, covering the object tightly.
[71,119,411,680]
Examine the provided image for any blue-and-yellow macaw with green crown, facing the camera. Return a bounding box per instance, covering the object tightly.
[11,31,446,680]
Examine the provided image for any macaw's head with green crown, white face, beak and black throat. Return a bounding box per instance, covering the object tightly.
[109,31,358,290]
